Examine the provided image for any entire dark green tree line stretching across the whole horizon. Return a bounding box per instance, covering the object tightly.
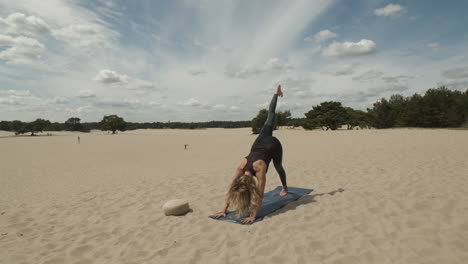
[0,87,468,136]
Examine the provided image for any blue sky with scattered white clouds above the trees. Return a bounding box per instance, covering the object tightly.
[0,0,468,122]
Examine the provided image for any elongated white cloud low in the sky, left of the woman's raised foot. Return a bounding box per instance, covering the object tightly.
[93,69,156,91]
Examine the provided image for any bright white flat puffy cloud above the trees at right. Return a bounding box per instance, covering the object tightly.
[322,39,376,57]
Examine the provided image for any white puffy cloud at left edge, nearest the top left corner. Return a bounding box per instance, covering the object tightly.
[0,13,50,36]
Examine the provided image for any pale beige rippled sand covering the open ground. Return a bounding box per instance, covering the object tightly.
[0,129,468,264]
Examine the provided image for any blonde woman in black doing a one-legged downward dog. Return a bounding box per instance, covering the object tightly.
[211,85,288,223]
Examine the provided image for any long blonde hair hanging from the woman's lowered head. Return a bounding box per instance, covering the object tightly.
[226,175,259,218]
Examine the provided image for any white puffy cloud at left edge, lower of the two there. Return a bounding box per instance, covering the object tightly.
[0,34,45,65]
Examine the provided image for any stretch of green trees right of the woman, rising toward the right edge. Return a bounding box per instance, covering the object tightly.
[252,87,468,133]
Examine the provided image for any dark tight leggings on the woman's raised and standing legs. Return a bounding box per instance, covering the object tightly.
[255,94,287,187]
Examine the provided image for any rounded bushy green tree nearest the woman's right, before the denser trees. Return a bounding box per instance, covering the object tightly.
[305,101,347,130]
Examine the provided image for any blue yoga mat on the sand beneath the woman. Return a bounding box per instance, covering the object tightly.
[209,186,313,225]
